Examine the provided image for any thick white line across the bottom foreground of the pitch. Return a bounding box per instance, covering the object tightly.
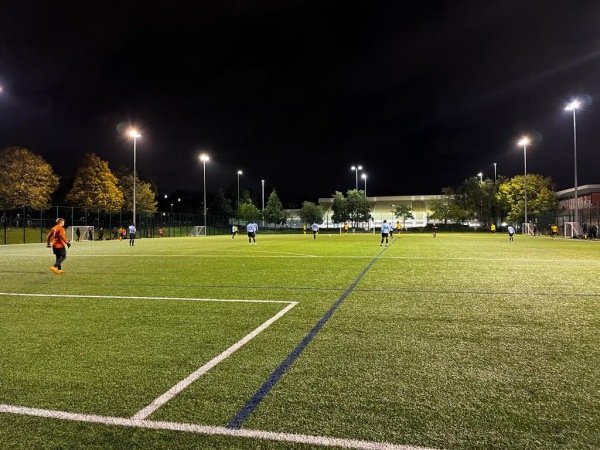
[0,405,435,450]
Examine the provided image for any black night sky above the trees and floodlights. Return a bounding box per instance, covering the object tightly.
[0,0,600,206]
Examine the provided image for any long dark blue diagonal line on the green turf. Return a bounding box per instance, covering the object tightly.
[227,247,387,429]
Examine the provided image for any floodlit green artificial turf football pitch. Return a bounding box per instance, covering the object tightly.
[0,233,600,449]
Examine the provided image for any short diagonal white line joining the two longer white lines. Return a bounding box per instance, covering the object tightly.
[132,302,298,420]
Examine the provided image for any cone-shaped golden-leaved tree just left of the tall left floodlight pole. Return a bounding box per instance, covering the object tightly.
[66,153,123,212]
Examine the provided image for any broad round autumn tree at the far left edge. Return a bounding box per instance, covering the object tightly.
[0,147,59,209]
